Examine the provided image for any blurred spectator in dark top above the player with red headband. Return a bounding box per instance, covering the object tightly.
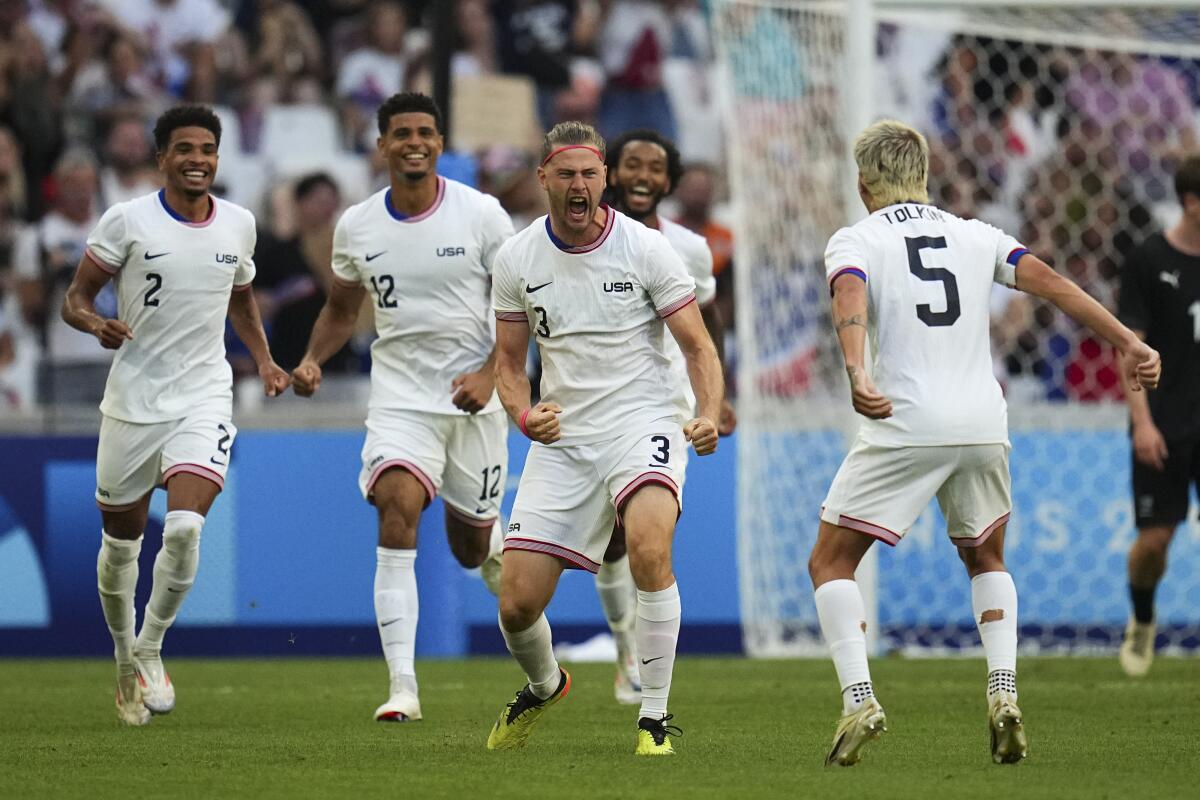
[492,0,601,130]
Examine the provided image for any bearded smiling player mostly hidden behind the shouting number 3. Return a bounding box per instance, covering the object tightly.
[596,130,737,704]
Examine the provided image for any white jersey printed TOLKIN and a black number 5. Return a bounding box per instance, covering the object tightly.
[826,203,1026,446]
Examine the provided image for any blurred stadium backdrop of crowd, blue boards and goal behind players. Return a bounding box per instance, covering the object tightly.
[0,0,1200,657]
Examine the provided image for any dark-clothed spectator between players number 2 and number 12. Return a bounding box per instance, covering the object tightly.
[254,173,359,374]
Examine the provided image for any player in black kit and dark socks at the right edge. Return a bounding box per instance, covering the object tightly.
[1118,155,1200,676]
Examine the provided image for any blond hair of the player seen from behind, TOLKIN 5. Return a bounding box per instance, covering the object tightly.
[854,120,929,207]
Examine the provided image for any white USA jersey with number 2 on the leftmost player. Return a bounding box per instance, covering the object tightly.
[88,190,257,422]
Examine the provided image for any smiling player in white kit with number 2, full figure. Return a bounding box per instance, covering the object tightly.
[62,106,288,724]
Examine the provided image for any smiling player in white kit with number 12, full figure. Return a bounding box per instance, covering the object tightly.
[293,94,512,722]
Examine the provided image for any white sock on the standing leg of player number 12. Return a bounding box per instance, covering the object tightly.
[374,547,419,694]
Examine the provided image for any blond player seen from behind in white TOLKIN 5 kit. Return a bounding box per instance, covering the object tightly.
[809,120,1160,766]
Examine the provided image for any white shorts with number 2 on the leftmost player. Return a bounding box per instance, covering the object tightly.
[96,408,238,511]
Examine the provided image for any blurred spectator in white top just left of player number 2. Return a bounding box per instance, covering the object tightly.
[13,149,109,402]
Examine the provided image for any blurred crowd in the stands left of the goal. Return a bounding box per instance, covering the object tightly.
[0,0,731,409]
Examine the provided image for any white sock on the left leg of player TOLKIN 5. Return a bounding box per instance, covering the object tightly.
[814,578,874,714]
